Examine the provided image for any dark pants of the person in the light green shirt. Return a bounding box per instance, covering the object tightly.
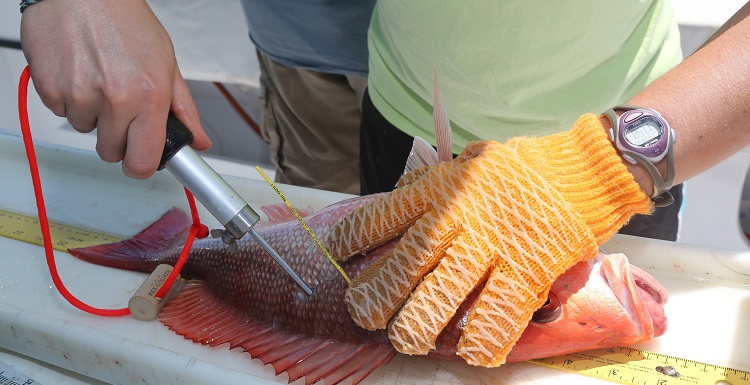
[359,92,682,241]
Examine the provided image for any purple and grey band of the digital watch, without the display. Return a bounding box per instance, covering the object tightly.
[604,104,675,207]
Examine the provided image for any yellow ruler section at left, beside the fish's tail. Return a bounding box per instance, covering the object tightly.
[0,210,122,252]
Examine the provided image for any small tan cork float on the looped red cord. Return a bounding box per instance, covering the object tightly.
[128,264,180,321]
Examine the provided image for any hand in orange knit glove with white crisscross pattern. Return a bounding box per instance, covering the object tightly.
[328,114,652,366]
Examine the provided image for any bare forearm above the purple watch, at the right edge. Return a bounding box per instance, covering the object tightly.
[628,1,750,190]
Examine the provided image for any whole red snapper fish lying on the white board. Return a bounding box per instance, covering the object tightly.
[70,196,667,384]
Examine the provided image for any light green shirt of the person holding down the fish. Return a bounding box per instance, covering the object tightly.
[368,0,682,152]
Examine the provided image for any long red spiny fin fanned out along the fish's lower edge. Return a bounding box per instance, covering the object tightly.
[159,282,396,385]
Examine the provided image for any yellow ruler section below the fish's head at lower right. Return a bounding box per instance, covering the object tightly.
[529,348,750,385]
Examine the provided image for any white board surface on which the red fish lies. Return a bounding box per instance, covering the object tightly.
[0,130,750,385]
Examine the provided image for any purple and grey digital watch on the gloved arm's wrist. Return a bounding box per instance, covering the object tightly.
[603,104,675,207]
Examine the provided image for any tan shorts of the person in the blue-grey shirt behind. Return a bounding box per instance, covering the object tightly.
[258,52,367,194]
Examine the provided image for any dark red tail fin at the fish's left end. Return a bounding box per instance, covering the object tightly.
[68,208,191,273]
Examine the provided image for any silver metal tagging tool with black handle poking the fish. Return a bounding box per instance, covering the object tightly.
[159,113,312,295]
